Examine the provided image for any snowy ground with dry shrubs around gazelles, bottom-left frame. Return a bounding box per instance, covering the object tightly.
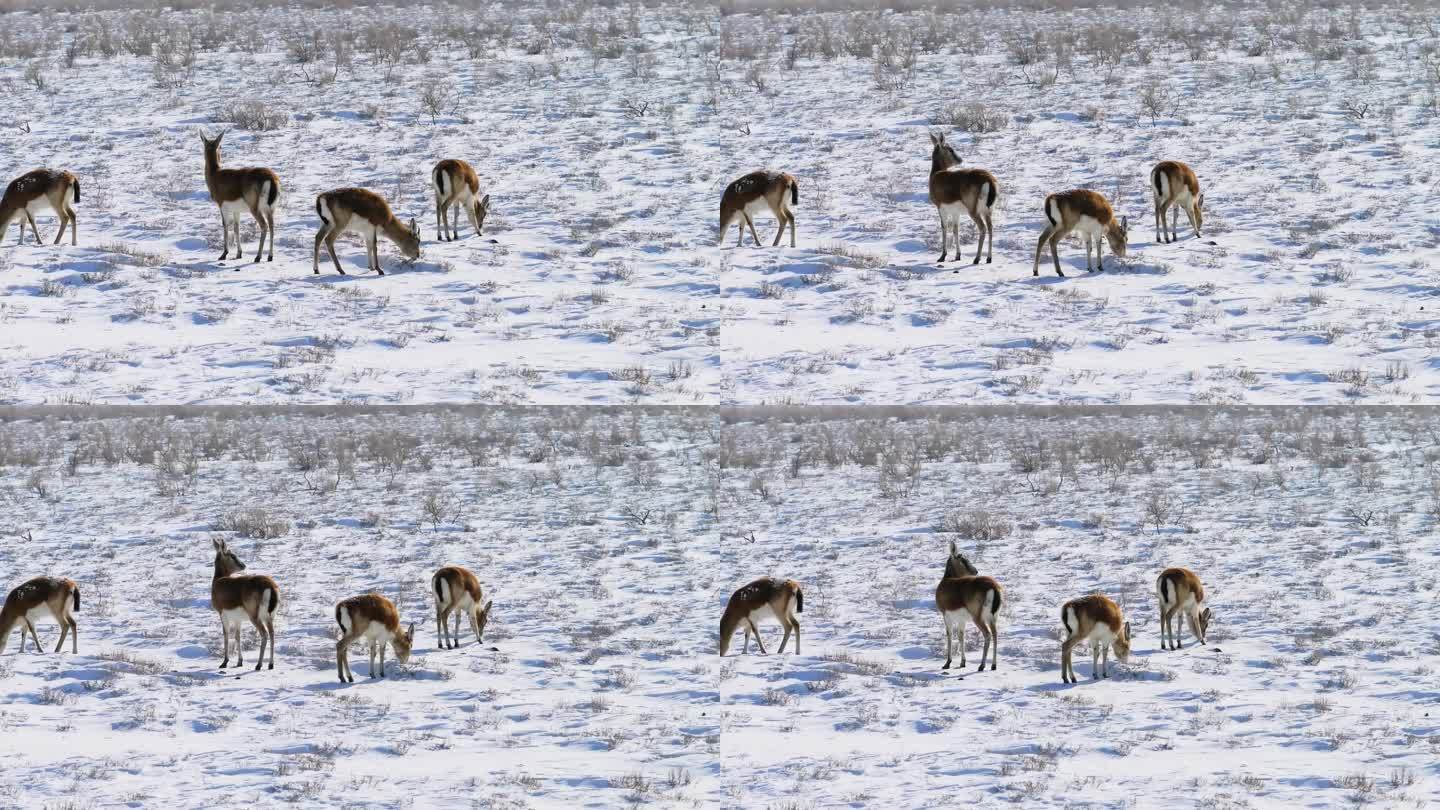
[0,408,720,809]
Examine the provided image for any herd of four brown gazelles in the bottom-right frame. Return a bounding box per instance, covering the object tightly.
[720,542,1210,683]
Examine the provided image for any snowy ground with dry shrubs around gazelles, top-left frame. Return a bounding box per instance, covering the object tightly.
[0,3,720,404]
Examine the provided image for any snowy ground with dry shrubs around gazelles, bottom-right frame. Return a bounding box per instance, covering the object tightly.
[725,408,1440,807]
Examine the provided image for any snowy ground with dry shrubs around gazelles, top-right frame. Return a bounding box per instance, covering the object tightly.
[725,4,1440,405]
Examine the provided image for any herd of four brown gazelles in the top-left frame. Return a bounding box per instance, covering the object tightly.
[0,133,490,275]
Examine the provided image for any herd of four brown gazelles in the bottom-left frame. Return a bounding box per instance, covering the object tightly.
[0,538,494,683]
